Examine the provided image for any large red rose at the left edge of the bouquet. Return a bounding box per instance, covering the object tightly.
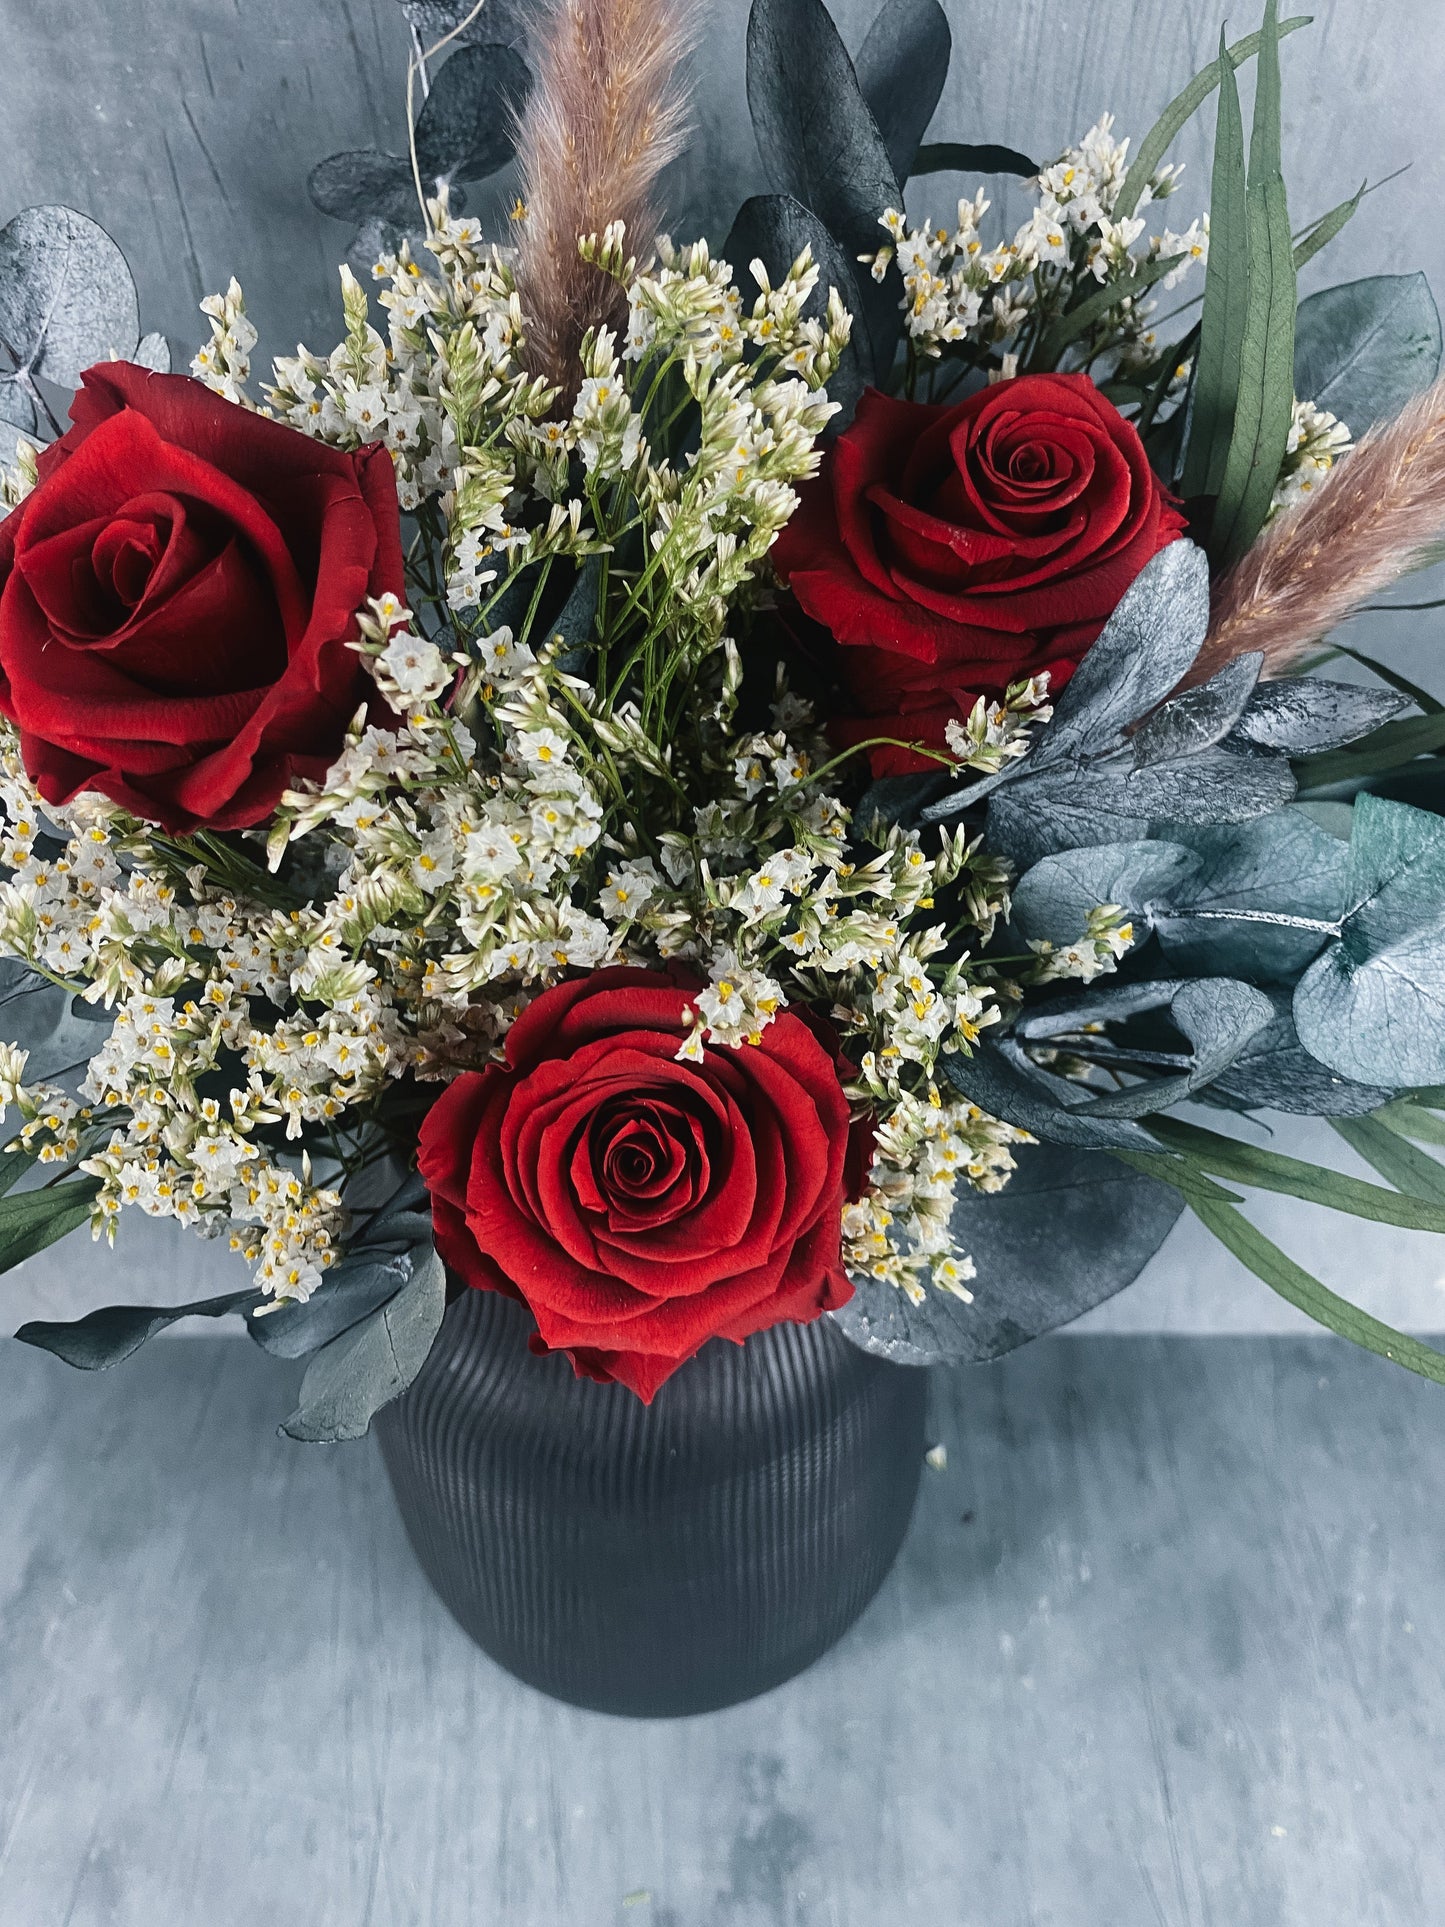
[0,362,405,831]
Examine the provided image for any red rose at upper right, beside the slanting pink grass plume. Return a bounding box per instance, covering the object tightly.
[773,374,1185,775]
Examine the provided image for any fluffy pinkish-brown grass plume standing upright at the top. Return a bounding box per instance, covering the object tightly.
[516,0,694,395]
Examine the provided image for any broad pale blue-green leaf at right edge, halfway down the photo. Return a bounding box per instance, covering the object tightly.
[1295,796,1445,1087]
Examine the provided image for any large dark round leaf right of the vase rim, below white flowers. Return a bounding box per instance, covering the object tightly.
[832,1145,1183,1364]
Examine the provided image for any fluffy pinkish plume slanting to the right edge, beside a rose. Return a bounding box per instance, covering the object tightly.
[1189,378,1445,682]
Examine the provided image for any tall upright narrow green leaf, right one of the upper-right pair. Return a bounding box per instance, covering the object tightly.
[1210,0,1297,567]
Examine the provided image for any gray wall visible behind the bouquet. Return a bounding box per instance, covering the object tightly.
[0,0,1445,1332]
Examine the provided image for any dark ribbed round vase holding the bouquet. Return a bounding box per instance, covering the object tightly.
[376,1291,927,1715]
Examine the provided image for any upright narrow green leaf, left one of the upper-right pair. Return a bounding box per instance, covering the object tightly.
[1179,33,1248,497]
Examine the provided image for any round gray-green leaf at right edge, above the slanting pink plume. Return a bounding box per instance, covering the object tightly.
[1295,274,1441,441]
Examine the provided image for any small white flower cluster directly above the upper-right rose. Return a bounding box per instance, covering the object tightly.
[869,114,1208,383]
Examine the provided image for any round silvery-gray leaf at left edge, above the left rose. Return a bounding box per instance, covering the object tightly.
[0,206,141,387]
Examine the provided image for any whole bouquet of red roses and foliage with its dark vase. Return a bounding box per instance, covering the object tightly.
[0,0,1445,1711]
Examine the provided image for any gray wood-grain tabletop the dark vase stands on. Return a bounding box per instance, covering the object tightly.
[0,1337,1445,1927]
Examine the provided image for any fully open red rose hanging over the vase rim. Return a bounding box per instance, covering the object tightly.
[420,967,857,1401]
